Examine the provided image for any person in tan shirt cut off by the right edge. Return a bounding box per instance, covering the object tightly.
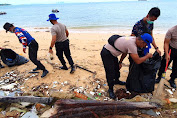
[156,25,177,88]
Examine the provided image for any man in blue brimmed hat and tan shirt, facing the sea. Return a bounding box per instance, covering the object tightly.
[47,14,75,74]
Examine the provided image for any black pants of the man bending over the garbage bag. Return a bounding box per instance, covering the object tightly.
[101,47,120,89]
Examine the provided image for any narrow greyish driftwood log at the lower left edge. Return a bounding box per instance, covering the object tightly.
[0,96,53,104]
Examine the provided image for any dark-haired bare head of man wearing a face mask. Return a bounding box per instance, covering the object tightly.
[146,7,160,24]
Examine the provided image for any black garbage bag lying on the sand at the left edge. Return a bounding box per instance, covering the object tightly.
[0,49,29,67]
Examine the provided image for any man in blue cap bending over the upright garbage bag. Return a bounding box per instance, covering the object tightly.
[101,33,153,99]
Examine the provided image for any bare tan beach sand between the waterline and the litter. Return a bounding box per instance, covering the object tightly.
[0,31,171,95]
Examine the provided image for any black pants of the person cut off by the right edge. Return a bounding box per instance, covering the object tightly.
[158,46,177,81]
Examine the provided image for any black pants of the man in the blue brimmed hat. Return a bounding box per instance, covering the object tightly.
[55,39,74,67]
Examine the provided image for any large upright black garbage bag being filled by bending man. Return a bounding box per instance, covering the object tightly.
[126,52,161,93]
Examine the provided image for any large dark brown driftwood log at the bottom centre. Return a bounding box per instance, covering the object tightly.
[51,100,158,118]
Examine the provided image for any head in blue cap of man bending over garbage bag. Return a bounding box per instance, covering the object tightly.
[136,33,153,49]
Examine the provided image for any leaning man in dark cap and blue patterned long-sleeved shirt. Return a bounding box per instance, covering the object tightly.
[3,22,48,78]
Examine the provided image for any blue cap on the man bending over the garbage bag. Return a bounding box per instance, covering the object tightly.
[141,33,153,49]
